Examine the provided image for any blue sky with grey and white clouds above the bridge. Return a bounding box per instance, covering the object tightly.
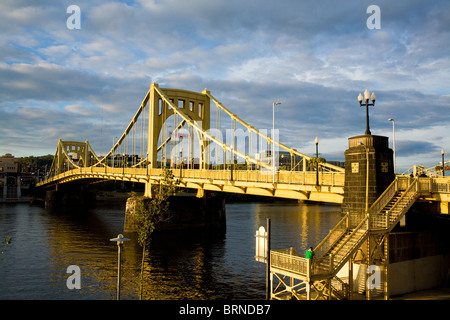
[0,0,450,171]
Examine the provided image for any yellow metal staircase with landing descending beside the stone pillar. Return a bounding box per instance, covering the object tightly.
[271,177,419,299]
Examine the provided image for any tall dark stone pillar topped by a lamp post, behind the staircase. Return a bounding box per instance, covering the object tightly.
[341,133,395,299]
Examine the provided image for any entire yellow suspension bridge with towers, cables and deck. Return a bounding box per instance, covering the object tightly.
[37,83,344,203]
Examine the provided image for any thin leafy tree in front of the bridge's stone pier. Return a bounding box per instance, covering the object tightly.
[134,168,179,299]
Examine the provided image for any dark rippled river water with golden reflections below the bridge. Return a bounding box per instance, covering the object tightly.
[0,201,340,300]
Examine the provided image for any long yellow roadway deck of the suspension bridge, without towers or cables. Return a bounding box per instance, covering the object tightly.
[37,167,344,203]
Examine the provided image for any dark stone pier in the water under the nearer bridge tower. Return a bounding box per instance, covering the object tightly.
[124,196,226,232]
